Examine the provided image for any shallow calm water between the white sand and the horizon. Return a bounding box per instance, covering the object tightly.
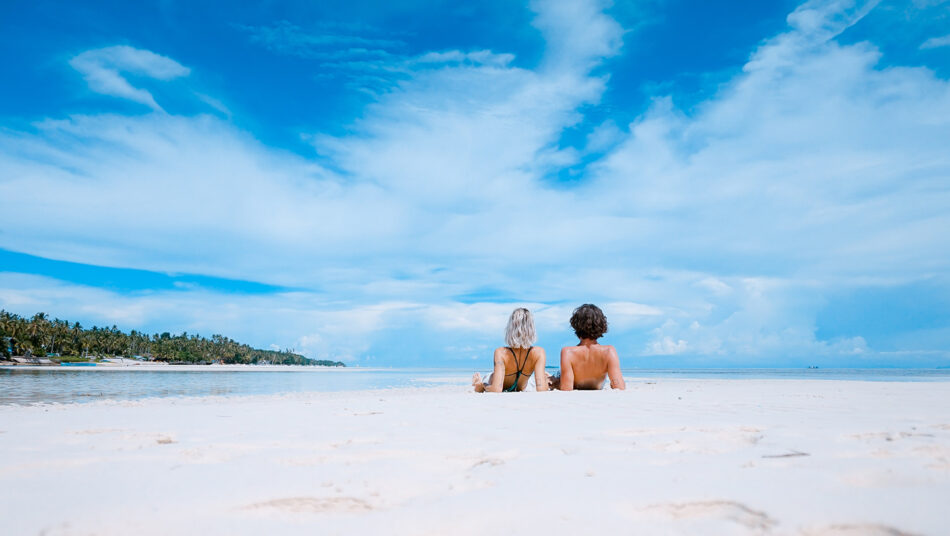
[0,366,950,405]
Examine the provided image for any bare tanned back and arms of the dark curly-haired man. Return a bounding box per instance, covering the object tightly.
[553,339,627,391]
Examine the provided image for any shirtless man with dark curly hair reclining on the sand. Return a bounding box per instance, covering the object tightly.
[549,303,627,391]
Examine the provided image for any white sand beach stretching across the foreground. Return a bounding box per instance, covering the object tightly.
[0,378,950,535]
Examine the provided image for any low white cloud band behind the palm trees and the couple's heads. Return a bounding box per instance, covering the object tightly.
[0,272,672,364]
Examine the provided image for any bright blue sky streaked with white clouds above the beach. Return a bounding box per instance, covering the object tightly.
[0,0,950,368]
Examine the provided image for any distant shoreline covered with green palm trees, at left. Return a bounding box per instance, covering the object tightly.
[0,310,346,367]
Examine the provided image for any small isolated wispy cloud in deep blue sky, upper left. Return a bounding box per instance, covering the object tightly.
[69,45,190,110]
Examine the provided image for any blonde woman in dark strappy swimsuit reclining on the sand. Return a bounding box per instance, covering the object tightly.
[472,307,548,393]
